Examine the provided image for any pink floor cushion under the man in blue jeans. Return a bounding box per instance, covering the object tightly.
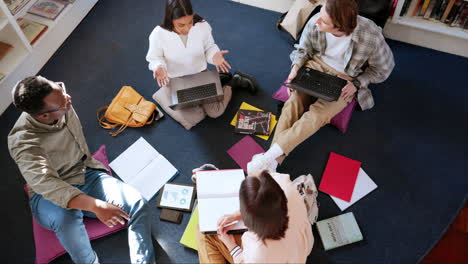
[24,145,126,264]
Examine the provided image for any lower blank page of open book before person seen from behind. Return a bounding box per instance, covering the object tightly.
[198,197,246,232]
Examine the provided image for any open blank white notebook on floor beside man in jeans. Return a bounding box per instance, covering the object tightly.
[109,137,179,200]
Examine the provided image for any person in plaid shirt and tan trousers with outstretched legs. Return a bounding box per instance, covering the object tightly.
[247,0,395,173]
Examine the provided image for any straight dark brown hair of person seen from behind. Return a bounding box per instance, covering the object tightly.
[239,171,289,243]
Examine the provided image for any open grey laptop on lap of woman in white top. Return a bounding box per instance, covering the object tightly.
[169,70,224,110]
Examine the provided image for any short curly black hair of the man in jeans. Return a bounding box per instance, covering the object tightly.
[13,76,53,115]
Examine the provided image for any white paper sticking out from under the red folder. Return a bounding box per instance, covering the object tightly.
[330,168,377,211]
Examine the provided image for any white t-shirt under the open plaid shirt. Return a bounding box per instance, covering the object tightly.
[321,32,351,73]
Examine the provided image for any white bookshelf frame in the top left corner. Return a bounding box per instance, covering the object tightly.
[0,0,98,114]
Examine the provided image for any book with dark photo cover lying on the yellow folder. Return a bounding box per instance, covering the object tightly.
[235,109,271,136]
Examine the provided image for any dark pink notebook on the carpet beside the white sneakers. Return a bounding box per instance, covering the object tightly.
[227,136,265,173]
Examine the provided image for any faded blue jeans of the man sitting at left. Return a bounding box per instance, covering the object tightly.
[29,168,154,263]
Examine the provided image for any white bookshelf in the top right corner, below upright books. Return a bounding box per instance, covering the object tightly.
[384,0,468,57]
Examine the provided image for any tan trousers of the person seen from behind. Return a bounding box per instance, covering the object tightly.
[197,227,242,264]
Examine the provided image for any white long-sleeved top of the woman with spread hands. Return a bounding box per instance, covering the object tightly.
[146,21,219,78]
